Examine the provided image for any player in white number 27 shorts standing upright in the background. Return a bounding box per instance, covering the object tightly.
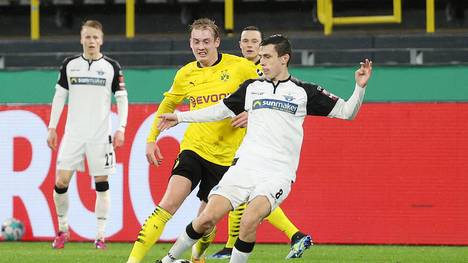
[47,20,128,249]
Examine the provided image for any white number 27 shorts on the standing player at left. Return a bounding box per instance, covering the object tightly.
[57,136,115,176]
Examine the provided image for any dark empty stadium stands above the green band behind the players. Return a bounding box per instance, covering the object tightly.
[0,0,468,69]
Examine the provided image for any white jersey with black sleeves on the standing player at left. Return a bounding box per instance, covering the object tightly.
[56,55,126,143]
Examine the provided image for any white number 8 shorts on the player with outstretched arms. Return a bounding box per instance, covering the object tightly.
[210,166,292,212]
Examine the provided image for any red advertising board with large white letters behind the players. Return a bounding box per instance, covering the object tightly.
[0,103,468,245]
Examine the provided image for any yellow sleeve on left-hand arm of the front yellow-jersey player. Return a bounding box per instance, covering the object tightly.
[146,69,186,142]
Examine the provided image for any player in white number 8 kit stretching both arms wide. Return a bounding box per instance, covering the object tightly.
[155,35,372,263]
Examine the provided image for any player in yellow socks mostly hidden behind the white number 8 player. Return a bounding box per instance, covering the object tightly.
[210,26,312,259]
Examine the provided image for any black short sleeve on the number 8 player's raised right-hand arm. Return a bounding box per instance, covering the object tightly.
[304,84,340,116]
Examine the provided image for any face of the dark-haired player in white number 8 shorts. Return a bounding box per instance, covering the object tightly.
[259,45,289,81]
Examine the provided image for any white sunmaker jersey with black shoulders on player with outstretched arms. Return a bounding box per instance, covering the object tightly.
[178,77,365,181]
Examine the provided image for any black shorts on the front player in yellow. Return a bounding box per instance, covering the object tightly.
[172,150,229,202]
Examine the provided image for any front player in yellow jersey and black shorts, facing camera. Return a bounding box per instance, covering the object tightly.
[127,18,258,263]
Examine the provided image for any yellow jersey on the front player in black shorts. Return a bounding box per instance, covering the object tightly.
[147,54,258,166]
